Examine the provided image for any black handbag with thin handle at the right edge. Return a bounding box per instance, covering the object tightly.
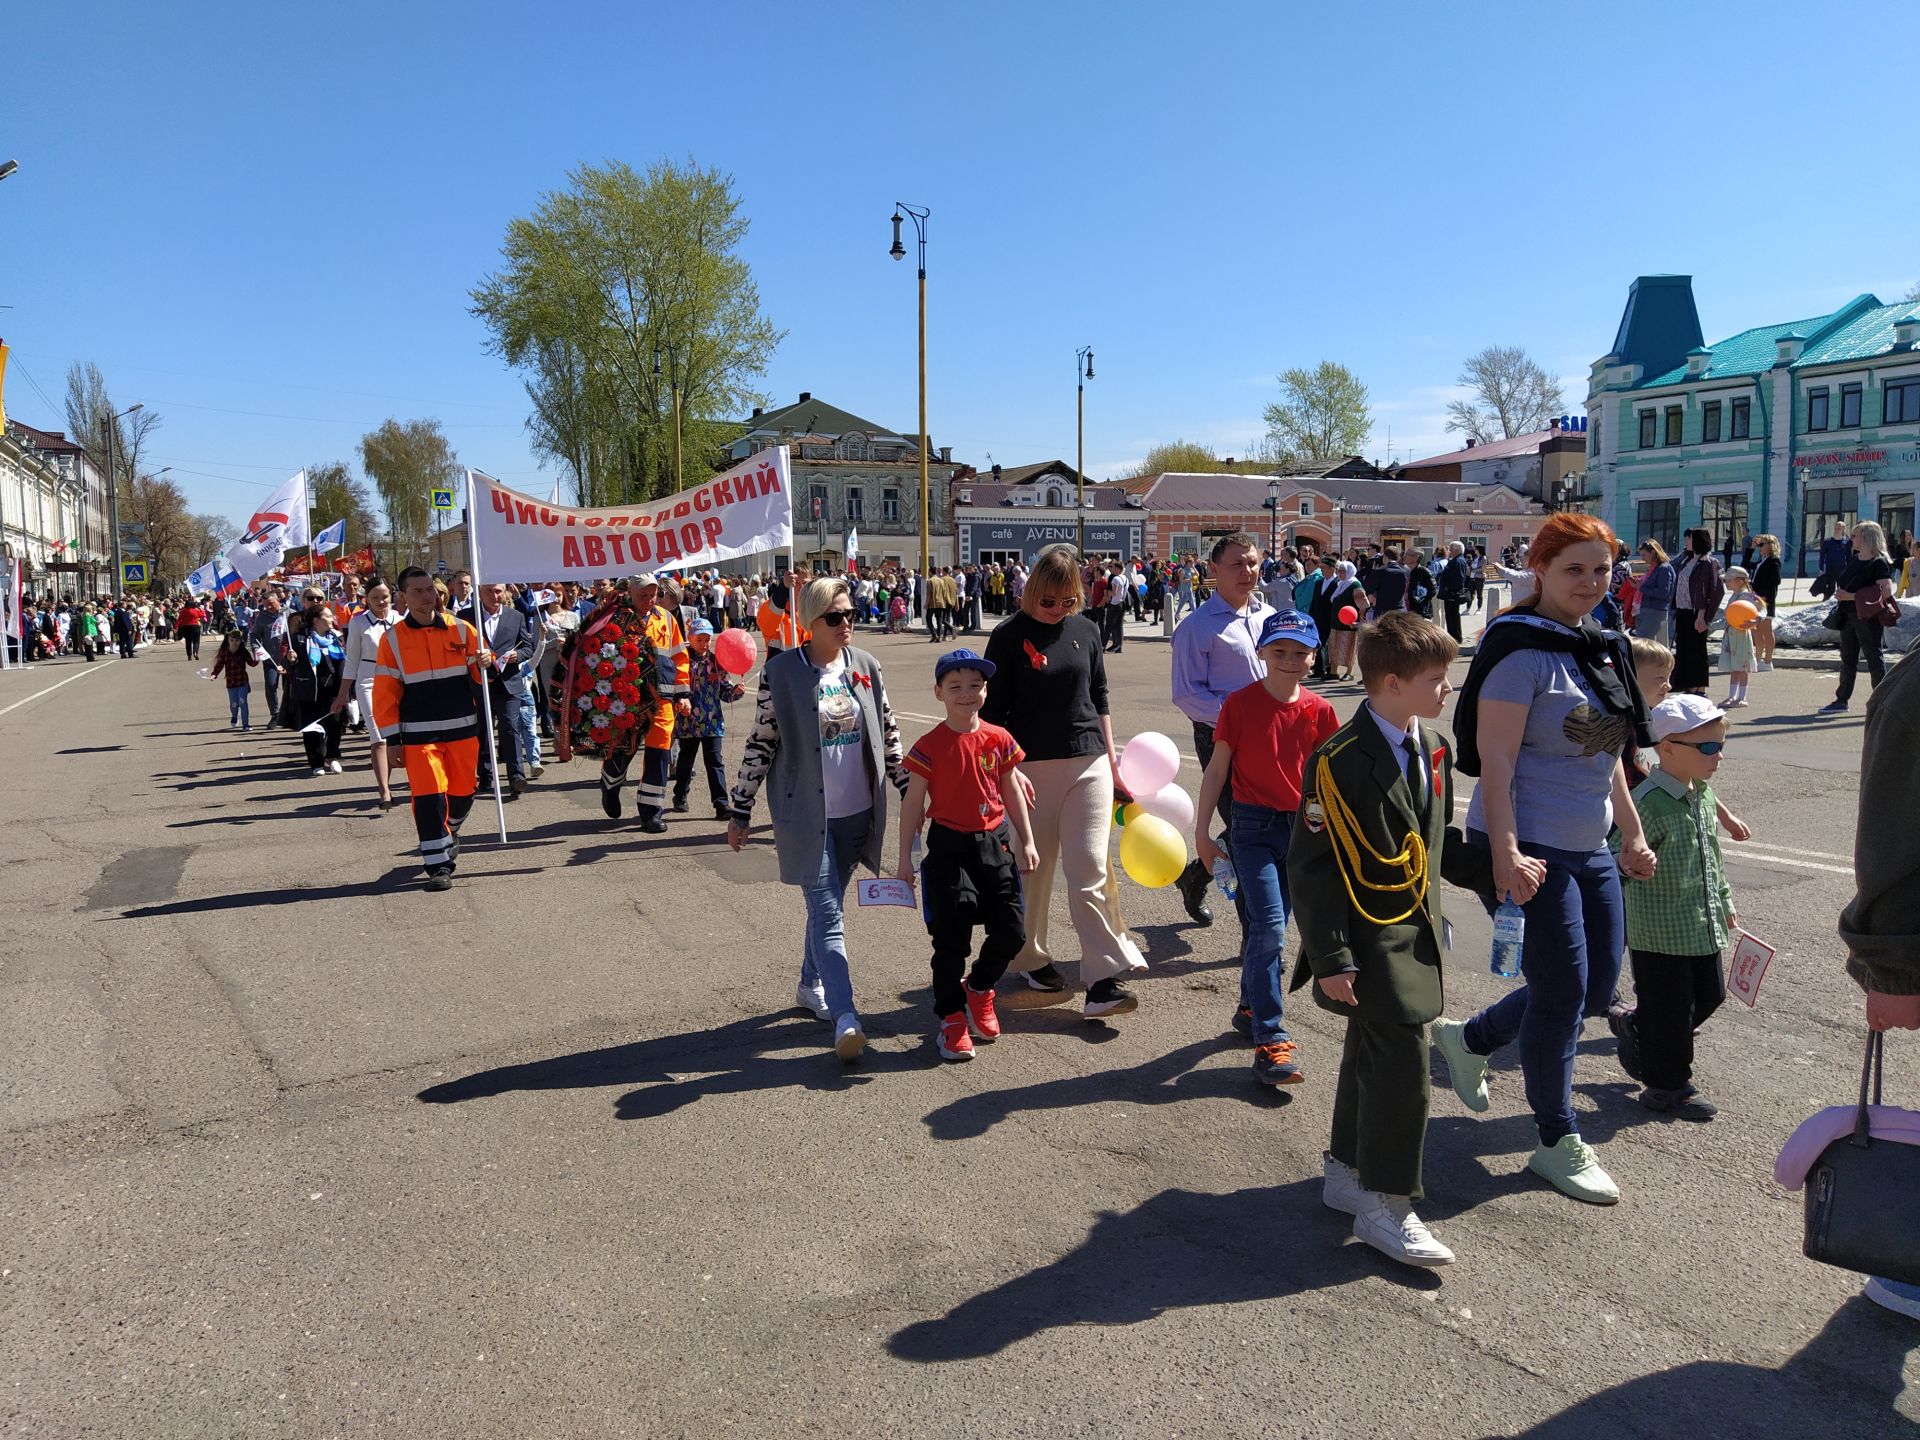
[1803,1031,1920,1284]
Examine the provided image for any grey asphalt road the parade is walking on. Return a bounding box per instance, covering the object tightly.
[0,622,1920,1440]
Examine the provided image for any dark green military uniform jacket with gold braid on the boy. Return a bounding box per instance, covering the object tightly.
[1286,705,1465,1025]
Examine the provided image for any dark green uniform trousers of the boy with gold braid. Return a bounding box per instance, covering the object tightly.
[1327,1016,1428,1200]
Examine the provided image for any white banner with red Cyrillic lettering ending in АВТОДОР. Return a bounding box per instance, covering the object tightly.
[468,445,793,584]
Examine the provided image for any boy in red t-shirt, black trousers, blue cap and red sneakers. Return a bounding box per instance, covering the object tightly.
[899,649,1039,1060]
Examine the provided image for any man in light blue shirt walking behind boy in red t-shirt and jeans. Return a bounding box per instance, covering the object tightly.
[1173,530,1273,929]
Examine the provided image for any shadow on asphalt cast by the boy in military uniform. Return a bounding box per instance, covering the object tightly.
[887,1177,1440,1365]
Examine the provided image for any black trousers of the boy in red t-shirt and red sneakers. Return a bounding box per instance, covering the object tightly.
[920,820,1027,1016]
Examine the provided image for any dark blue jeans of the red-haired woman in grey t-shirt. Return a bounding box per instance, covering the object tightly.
[1465,833,1626,1144]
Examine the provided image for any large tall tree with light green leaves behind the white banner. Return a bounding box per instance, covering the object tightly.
[472,161,781,505]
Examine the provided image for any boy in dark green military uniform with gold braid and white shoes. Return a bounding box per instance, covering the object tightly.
[1286,611,1471,1265]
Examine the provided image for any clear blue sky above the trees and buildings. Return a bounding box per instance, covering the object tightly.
[0,0,1920,518]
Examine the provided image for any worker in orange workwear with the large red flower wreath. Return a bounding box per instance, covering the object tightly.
[555,574,691,835]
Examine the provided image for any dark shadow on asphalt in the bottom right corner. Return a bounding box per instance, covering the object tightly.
[1488,1298,1920,1440]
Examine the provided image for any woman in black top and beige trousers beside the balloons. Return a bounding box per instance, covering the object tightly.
[981,545,1146,1020]
